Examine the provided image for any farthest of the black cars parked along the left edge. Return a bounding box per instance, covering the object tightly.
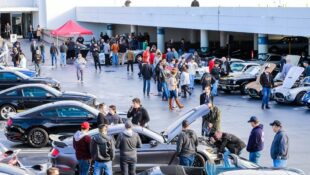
[0,70,60,90]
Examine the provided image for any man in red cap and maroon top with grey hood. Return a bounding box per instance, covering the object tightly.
[73,122,91,175]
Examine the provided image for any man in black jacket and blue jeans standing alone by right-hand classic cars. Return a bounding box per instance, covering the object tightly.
[259,65,274,109]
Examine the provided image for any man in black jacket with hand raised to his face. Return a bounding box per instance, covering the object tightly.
[127,98,150,127]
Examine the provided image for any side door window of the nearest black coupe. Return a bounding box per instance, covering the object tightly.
[57,106,95,118]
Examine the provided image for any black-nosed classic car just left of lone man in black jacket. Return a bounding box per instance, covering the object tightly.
[218,66,261,94]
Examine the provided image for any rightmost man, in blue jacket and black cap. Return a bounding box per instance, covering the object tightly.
[270,120,289,168]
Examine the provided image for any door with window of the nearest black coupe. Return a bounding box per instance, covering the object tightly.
[57,106,95,133]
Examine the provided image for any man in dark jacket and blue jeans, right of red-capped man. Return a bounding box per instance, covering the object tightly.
[90,123,115,175]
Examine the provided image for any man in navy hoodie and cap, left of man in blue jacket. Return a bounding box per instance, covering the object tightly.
[246,116,264,163]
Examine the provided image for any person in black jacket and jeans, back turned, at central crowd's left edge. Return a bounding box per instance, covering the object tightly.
[141,62,153,96]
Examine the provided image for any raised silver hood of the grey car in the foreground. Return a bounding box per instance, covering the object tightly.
[162,105,210,142]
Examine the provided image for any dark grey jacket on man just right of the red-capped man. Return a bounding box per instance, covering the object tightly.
[90,134,115,162]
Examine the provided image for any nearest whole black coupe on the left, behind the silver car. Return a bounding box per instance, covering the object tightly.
[5,100,122,147]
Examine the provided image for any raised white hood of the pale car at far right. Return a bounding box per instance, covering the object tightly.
[282,66,304,89]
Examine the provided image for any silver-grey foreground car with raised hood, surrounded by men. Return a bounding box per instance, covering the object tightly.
[48,105,212,174]
